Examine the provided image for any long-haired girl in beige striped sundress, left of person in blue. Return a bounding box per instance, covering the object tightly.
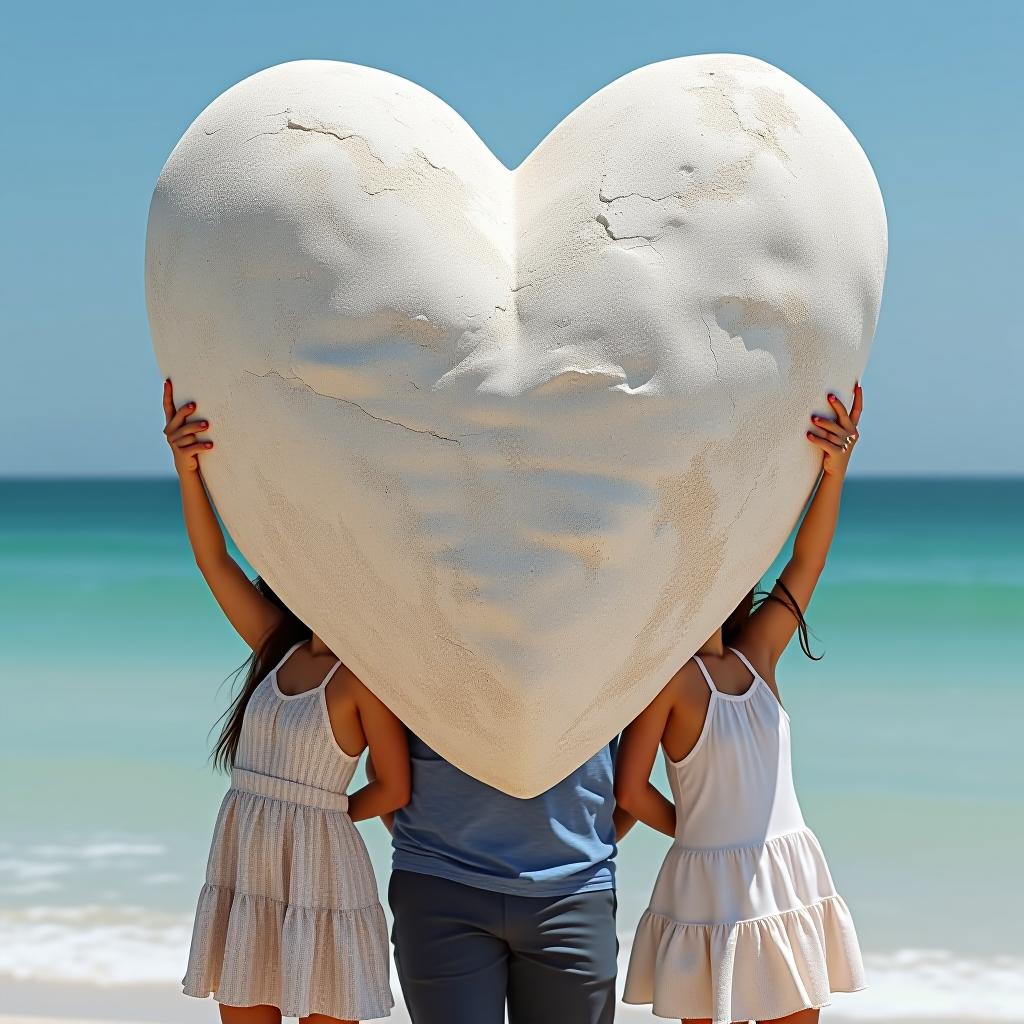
[164,381,410,1024]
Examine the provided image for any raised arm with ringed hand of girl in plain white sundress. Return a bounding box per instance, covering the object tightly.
[739,383,864,678]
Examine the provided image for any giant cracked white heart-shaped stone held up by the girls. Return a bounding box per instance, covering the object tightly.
[146,55,886,797]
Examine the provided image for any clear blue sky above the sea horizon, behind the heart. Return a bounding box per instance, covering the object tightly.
[0,0,1024,475]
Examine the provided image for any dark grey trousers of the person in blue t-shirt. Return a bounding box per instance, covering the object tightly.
[388,871,618,1024]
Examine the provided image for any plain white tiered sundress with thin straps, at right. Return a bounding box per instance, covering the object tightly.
[624,648,864,1024]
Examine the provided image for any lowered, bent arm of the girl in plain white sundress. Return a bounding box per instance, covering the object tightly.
[615,683,676,836]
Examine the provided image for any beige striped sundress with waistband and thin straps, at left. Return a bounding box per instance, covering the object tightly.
[182,644,394,1021]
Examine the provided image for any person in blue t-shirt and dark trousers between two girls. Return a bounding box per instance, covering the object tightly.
[389,735,617,1024]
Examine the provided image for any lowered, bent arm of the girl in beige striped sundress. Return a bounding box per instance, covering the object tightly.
[348,682,412,829]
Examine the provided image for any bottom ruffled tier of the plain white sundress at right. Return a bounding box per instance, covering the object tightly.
[623,895,865,1024]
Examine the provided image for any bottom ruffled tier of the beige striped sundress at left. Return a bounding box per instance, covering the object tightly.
[181,884,394,1021]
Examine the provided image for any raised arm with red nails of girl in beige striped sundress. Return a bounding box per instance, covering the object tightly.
[164,380,281,650]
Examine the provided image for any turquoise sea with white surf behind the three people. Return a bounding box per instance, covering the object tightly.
[0,479,1024,1021]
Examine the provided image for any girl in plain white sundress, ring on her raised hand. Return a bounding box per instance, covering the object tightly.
[615,384,864,1024]
